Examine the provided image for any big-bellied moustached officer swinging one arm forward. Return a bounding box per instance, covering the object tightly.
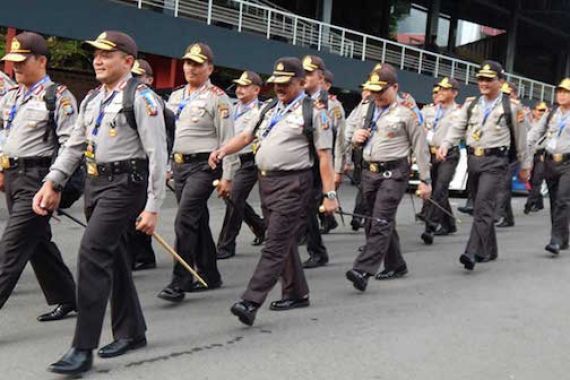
[210,57,338,325]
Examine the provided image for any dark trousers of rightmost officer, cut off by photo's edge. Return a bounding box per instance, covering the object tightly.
[544,159,570,246]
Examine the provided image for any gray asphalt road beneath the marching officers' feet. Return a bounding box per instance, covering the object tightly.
[0,186,570,380]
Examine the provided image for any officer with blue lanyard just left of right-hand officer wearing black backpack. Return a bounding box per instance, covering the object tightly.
[421,77,459,244]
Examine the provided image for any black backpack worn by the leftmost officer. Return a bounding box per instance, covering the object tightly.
[43,83,86,209]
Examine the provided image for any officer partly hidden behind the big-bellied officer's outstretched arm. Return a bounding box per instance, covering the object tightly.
[218,70,265,259]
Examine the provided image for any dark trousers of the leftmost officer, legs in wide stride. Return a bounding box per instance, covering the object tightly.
[0,167,75,308]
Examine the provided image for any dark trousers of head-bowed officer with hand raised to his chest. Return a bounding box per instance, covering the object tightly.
[353,159,410,275]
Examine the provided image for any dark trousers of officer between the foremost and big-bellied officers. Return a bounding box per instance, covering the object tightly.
[171,162,222,289]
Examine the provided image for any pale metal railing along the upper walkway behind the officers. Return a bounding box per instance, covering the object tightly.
[115,0,555,103]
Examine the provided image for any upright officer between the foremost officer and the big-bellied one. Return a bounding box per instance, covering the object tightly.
[158,42,239,302]
